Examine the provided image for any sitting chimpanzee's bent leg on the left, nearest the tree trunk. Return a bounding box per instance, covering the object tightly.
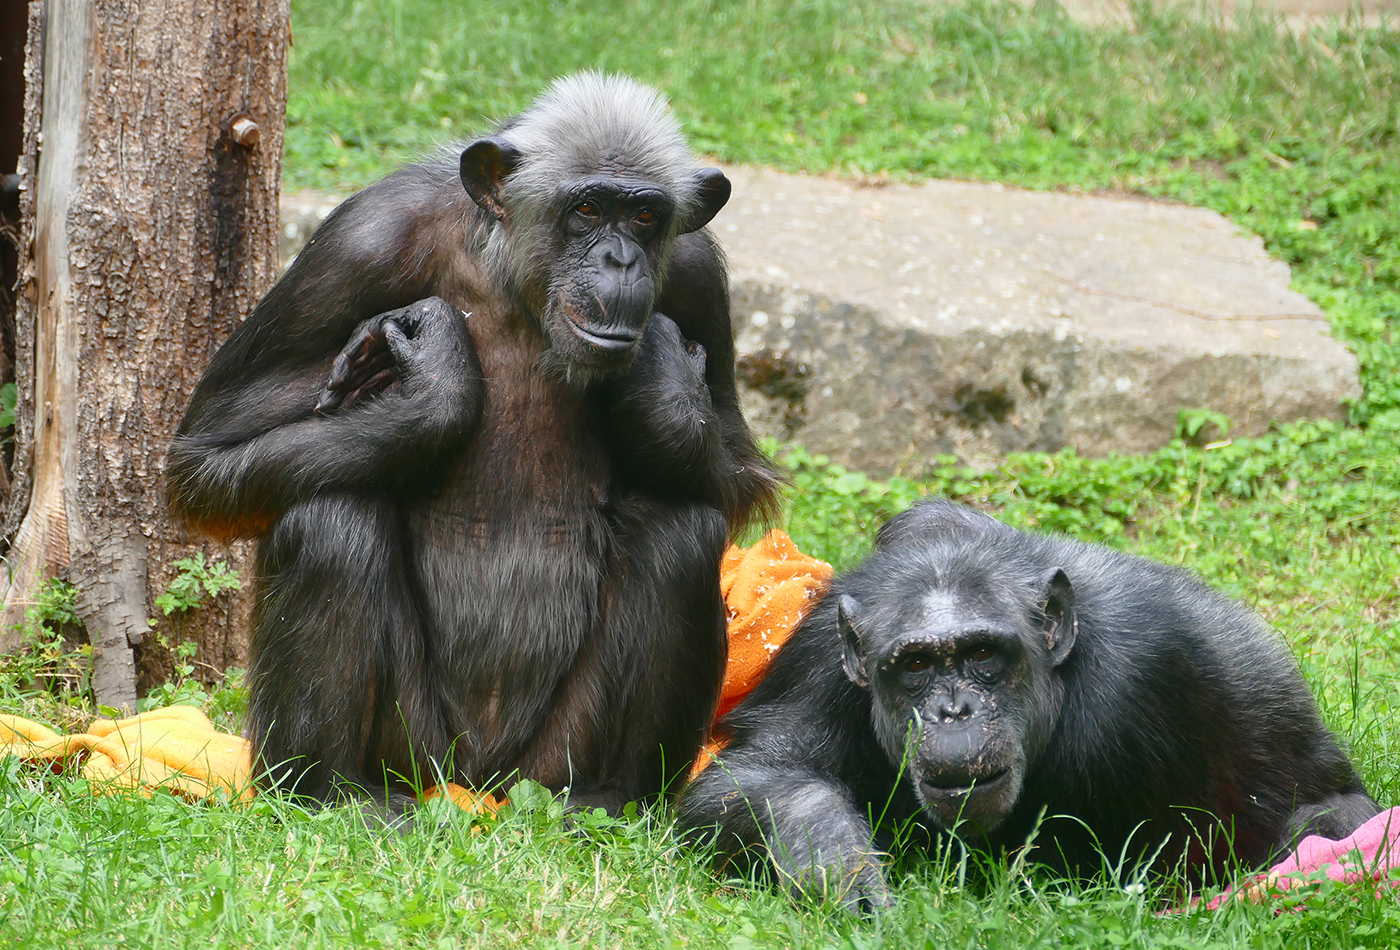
[248,495,445,800]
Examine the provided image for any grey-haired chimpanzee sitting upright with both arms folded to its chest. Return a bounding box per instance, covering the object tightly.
[169,73,777,809]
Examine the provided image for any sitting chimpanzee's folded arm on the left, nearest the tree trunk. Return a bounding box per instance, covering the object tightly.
[169,168,482,536]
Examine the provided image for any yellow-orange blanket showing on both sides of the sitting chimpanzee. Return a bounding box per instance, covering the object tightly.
[0,532,832,813]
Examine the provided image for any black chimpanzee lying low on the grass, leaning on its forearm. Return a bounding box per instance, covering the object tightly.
[680,501,1378,907]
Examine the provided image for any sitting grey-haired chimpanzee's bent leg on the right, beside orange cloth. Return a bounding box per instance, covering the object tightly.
[522,498,728,811]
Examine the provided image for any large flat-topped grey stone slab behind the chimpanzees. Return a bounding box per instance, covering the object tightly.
[714,168,1359,472]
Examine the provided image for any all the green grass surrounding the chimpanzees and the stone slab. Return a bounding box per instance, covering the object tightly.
[0,0,1400,949]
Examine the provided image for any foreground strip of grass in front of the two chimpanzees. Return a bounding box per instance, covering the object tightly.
[8,760,1400,950]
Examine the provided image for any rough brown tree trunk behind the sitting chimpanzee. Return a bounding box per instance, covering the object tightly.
[3,0,288,708]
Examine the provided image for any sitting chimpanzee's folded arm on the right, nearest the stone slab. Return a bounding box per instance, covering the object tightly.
[608,231,780,526]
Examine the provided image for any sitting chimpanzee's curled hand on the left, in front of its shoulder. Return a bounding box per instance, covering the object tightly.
[316,297,480,413]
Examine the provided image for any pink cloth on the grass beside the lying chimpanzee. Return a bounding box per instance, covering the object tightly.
[1205,807,1400,911]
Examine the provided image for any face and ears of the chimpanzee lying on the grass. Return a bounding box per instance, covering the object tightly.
[837,569,1074,834]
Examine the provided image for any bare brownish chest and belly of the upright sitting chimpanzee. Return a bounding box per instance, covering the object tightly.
[406,372,613,761]
